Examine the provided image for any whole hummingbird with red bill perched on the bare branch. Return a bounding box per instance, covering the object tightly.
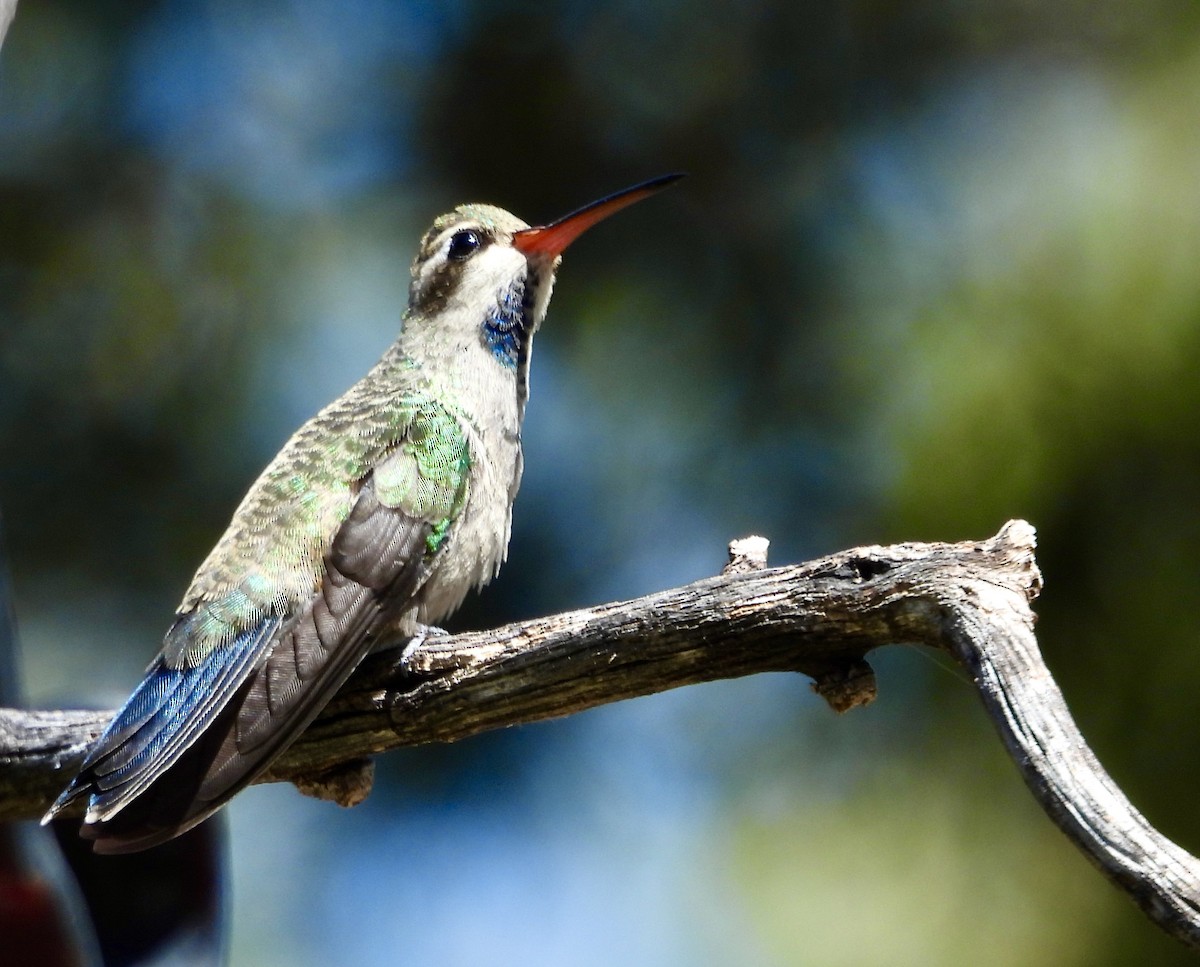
[42,174,682,853]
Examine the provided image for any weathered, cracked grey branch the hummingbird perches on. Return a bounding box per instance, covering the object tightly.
[0,521,1200,947]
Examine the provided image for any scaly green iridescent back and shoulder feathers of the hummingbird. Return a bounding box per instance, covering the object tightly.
[164,350,470,667]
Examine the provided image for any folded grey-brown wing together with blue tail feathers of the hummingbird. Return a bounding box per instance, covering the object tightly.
[62,475,442,853]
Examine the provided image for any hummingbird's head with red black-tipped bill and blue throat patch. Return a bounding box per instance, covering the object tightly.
[409,174,683,370]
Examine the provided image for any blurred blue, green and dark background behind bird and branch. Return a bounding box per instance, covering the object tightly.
[0,0,1200,967]
